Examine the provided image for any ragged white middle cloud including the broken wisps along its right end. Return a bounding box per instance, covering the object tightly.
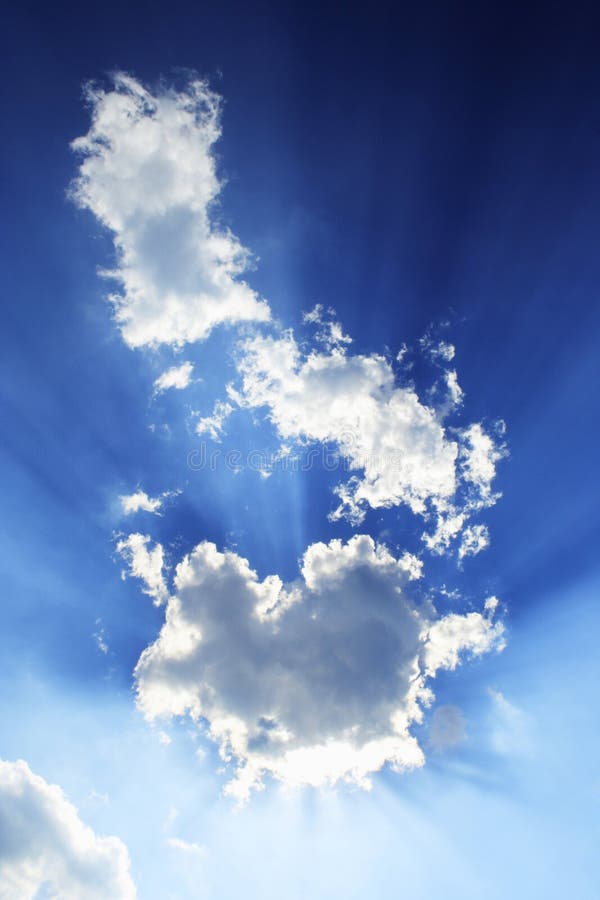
[228,324,504,552]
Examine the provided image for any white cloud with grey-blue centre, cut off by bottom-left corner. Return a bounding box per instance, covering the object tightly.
[0,760,137,900]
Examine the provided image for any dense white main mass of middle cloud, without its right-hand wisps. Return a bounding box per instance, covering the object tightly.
[232,332,458,523]
